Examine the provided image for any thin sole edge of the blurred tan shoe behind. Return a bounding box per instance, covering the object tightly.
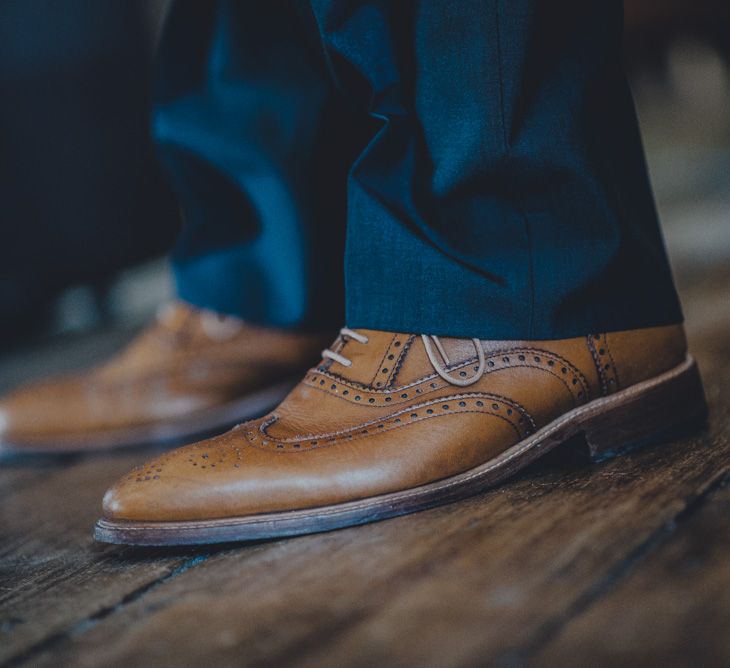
[0,377,299,456]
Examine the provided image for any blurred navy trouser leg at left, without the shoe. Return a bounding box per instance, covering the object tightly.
[153,0,358,331]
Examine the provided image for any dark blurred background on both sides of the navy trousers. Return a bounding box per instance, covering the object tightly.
[0,0,730,376]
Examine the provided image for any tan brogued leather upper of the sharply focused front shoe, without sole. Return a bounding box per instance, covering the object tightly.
[104,325,686,521]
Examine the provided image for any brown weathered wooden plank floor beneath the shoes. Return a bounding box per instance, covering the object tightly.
[0,272,730,668]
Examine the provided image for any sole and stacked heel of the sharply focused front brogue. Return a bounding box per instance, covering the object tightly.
[94,356,707,546]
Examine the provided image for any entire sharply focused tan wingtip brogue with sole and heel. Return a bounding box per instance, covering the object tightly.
[96,325,706,545]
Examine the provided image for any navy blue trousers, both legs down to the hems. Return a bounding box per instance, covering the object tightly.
[153,0,681,339]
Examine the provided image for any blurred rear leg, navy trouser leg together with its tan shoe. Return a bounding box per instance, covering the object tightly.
[0,0,367,453]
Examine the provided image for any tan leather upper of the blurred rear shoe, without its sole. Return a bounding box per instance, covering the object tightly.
[0,302,323,442]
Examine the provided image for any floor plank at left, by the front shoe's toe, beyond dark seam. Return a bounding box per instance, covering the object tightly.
[0,452,202,662]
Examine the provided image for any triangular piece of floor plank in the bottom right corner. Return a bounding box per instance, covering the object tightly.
[536,480,730,667]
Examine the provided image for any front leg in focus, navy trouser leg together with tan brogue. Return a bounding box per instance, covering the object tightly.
[97,0,706,545]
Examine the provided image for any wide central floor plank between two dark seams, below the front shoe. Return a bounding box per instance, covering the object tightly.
[18,350,730,666]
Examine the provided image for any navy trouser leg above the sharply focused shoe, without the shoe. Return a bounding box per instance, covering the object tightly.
[313,0,681,339]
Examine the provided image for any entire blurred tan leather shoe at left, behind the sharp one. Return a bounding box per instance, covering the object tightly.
[0,302,331,453]
